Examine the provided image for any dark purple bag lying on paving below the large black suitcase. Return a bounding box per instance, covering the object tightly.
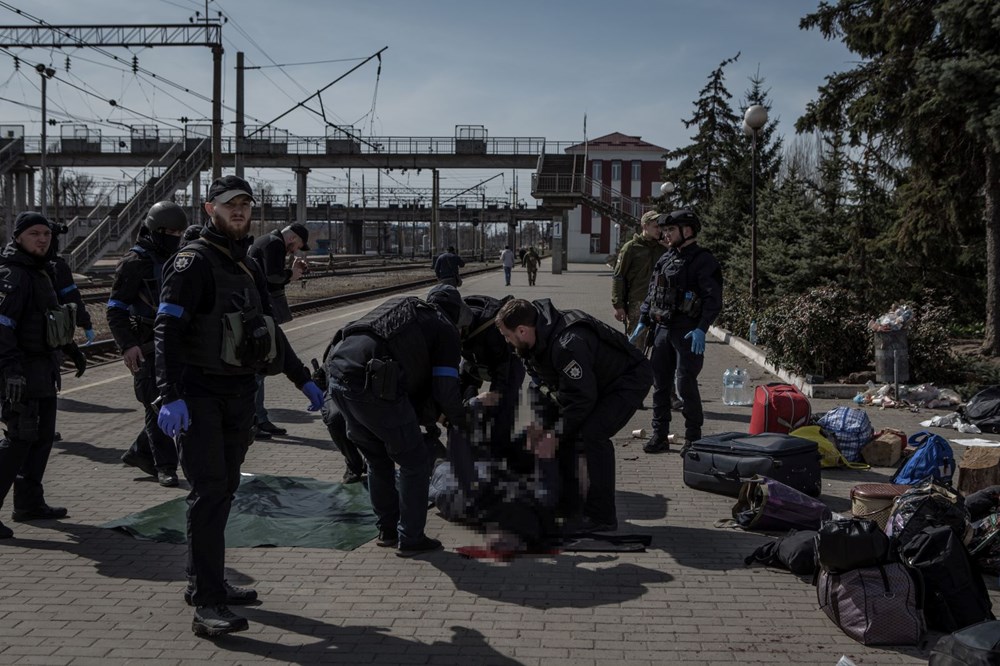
[733,475,831,532]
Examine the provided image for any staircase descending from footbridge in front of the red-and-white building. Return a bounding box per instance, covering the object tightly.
[531,154,652,230]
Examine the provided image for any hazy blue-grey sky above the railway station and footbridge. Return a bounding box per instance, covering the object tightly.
[0,0,854,198]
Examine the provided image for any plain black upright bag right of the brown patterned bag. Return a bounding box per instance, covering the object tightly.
[899,525,996,632]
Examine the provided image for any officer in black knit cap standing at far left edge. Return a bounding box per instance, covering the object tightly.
[0,213,86,539]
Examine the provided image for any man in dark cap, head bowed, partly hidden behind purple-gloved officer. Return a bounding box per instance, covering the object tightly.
[247,222,309,439]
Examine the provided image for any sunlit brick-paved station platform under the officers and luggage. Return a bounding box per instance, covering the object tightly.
[0,262,1000,666]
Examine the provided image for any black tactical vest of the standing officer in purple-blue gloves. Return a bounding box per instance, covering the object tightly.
[184,238,283,375]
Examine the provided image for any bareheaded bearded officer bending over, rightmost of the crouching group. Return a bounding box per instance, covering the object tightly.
[496,299,653,532]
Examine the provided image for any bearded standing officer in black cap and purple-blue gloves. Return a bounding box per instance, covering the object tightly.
[154,176,323,636]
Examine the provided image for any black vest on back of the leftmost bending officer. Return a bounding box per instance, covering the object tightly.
[341,296,437,395]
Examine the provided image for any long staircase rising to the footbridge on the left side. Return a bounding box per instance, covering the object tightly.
[65,138,212,273]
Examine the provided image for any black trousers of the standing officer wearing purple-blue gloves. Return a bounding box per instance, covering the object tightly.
[179,394,254,606]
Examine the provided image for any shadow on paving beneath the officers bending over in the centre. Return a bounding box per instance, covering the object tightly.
[426,548,673,610]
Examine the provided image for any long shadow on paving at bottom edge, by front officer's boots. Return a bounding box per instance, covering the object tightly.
[221,607,519,666]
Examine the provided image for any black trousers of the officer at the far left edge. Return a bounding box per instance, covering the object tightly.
[0,396,56,510]
